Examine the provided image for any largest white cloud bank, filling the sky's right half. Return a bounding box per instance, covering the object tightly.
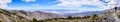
[55,0,118,10]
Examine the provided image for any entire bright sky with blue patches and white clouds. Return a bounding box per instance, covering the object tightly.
[0,0,120,12]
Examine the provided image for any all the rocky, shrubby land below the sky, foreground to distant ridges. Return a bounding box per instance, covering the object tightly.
[0,7,120,22]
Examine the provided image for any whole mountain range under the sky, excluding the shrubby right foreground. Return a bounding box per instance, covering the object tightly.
[0,8,114,22]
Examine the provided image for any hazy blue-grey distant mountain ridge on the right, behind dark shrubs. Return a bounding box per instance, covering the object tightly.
[64,8,115,17]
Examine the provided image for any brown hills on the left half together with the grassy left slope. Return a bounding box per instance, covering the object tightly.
[0,9,63,22]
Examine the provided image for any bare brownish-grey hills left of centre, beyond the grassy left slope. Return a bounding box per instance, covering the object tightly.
[9,10,64,20]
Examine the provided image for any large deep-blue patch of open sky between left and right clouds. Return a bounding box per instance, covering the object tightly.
[9,0,59,9]
